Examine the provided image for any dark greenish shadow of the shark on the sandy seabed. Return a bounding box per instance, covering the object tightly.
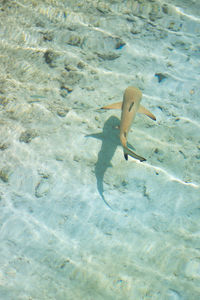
[86,116,120,209]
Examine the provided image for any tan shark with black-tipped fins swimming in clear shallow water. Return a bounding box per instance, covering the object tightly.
[101,86,156,162]
